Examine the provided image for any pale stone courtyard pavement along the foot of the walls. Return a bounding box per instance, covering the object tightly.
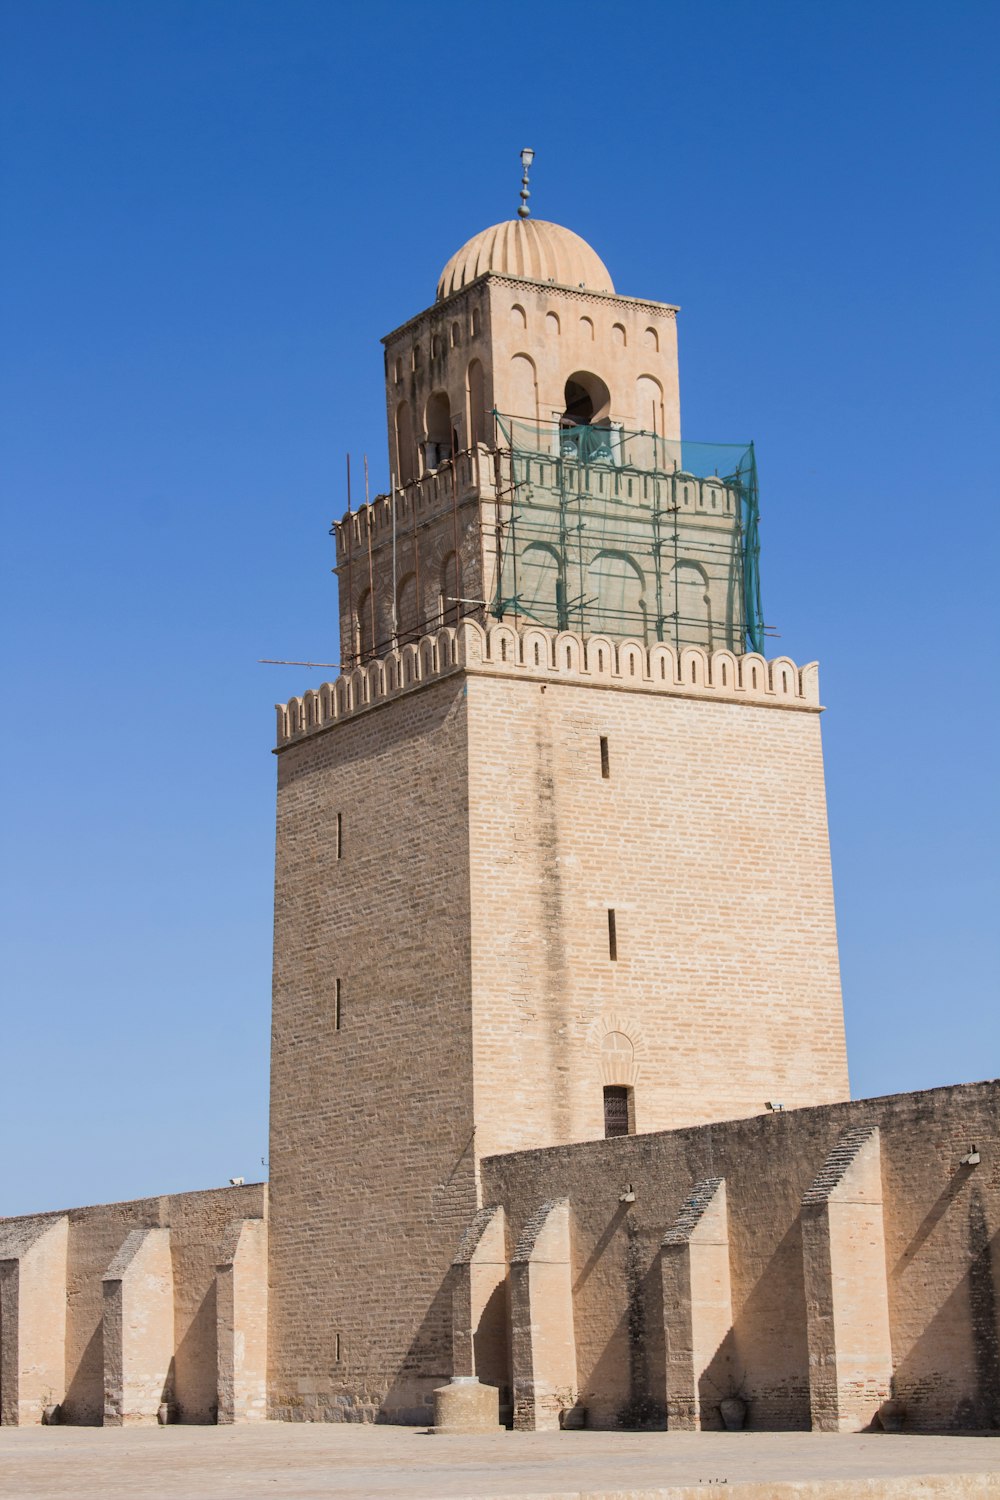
[0,1422,1000,1500]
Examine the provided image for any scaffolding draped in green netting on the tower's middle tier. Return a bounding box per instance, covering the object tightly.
[490,411,763,651]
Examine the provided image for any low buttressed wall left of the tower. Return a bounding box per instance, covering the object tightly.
[0,1184,267,1425]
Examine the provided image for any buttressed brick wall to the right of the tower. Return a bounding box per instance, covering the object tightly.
[483,1082,1000,1433]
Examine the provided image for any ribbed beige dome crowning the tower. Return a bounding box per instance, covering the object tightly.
[438,219,615,302]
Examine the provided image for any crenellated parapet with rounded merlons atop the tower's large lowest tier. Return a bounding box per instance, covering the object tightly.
[276,620,822,750]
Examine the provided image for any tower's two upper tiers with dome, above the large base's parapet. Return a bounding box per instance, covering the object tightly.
[334,219,762,665]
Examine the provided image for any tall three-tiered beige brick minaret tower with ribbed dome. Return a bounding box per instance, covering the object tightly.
[270,170,847,1421]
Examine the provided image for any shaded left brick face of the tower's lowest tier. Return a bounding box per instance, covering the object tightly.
[270,675,475,1422]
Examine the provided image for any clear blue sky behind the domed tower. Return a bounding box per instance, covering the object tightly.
[0,0,1000,1212]
